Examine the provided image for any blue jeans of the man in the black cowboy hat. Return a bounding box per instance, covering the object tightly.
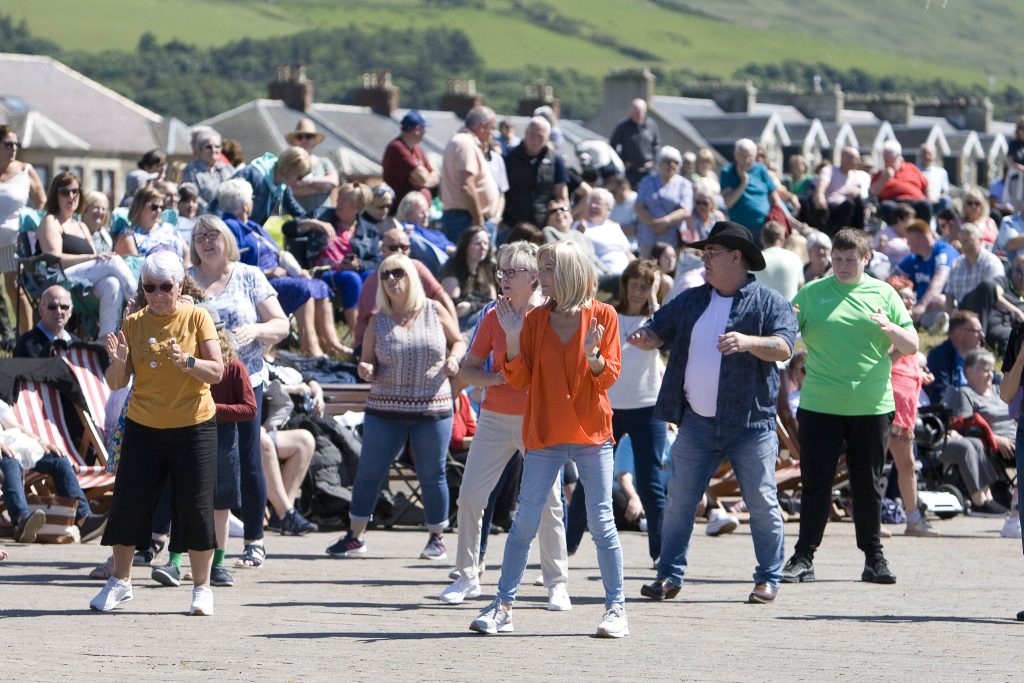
[657,411,785,586]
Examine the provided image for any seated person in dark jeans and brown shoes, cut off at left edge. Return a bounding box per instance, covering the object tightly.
[0,400,106,543]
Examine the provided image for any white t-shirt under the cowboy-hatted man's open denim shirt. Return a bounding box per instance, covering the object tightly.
[683,289,732,418]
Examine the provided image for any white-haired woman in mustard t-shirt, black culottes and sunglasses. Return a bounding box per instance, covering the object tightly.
[89,252,224,616]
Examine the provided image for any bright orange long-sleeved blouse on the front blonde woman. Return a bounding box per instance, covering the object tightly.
[502,301,622,451]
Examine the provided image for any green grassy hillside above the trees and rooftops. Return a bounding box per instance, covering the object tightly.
[0,0,1024,90]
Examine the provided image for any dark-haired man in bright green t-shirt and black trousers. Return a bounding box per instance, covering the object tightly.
[782,228,918,584]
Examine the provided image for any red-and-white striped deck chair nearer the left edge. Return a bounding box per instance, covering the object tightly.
[12,380,114,500]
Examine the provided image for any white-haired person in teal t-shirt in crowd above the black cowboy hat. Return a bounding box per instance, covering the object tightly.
[721,137,782,241]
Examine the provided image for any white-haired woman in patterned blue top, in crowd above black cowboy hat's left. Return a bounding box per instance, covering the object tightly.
[634,145,693,258]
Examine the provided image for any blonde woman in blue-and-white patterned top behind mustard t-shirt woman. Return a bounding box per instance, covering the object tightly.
[188,214,294,568]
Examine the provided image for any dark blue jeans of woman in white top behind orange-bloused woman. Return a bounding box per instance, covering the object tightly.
[565,405,669,560]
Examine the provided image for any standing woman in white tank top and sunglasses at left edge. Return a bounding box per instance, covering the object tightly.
[0,124,46,334]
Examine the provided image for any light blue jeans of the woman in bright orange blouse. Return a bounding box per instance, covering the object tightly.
[498,441,626,608]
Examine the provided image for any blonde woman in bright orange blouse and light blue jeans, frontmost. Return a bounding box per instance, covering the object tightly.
[470,242,629,638]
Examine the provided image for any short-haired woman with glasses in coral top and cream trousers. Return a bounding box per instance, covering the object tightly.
[439,242,572,610]
